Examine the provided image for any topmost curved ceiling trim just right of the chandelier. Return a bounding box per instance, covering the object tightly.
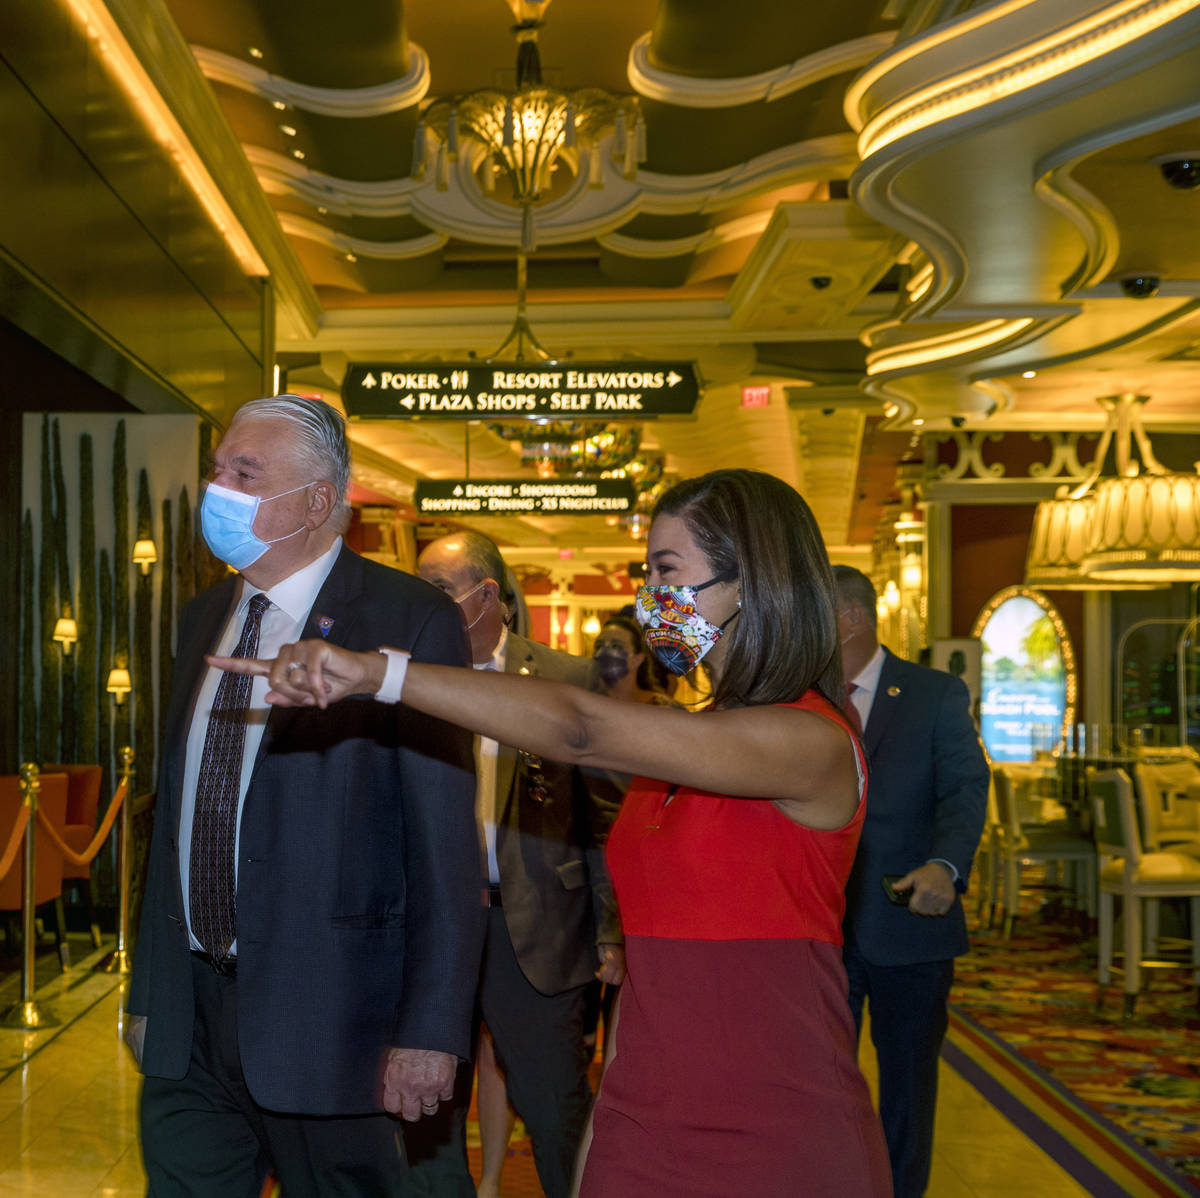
[628,31,895,108]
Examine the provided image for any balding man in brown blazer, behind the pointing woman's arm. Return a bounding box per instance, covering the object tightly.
[406,532,624,1198]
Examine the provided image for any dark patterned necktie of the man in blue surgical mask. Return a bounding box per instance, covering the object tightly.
[187,594,271,960]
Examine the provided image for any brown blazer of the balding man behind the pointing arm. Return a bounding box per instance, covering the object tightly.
[496,633,623,994]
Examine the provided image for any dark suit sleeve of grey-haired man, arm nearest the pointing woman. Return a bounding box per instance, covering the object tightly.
[392,604,484,1059]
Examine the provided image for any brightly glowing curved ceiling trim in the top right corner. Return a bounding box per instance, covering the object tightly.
[847,0,1200,161]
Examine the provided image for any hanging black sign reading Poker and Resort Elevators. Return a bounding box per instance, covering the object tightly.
[342,361,700,420]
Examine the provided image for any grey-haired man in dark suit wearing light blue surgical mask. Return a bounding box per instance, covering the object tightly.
[126,395,482,1198]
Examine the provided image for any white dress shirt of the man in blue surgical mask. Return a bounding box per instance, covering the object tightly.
[179,537,342,953]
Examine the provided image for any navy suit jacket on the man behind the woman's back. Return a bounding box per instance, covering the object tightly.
[845,649,988,965]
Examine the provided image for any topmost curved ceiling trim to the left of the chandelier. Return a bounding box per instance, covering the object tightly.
[192,42,431,119]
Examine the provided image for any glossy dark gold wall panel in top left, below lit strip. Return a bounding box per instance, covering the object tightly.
[0,0,274,423]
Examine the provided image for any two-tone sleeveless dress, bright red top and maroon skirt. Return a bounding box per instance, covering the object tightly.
[580,691,892,1198]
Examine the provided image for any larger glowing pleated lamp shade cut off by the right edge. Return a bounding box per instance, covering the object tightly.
[1081,472,1200,585]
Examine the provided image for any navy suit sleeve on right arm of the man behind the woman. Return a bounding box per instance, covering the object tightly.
[930,678,988,891]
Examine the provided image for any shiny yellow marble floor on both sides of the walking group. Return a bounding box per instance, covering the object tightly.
[0,953,1087,1198]
